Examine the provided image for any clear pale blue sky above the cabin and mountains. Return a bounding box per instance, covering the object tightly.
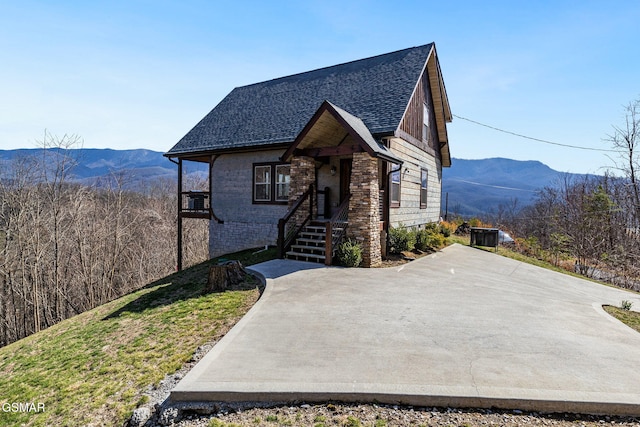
[0,0,640,173]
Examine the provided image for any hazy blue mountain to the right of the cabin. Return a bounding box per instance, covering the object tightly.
[442,158,592,216]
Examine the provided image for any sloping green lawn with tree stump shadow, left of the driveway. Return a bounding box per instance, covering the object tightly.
[0,249,275,426]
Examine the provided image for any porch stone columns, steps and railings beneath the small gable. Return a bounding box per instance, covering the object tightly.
[277,152,385,267]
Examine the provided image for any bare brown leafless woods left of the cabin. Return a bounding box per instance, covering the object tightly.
[0,135,208,346]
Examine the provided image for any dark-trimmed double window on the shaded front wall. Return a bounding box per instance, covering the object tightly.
[253,163,290,204]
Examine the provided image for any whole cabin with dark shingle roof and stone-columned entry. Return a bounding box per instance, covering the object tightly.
[165,43,452,267]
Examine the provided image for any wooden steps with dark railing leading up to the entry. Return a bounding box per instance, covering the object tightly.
[286,221,347,265]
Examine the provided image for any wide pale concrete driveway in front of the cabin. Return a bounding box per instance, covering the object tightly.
[170,245,640,415]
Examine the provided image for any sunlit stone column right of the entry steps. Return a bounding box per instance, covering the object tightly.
[348,153,382,267]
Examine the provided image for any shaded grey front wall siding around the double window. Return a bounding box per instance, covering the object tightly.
[209,150,287,258]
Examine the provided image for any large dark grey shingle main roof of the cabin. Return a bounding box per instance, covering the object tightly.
[166,43,433,156]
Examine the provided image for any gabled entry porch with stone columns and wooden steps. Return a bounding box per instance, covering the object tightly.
[278,101,402,267]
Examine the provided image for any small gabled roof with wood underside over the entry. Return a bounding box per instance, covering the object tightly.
[282,101,402,164]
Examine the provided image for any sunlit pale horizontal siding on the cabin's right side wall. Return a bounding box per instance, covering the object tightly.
[389,138,442,227]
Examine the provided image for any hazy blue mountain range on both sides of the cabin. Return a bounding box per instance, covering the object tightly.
[0,148,592,217]
